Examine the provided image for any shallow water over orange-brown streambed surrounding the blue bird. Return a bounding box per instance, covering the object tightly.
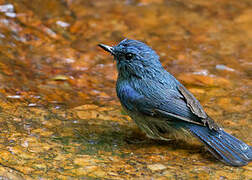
[0,0,252,179]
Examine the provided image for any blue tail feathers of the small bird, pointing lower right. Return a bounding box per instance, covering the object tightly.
[188,124,252,166]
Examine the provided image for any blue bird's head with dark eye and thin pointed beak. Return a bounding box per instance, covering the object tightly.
[99,39,162,78]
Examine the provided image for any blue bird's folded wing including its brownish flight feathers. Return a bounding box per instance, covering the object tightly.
[118,85,219,129]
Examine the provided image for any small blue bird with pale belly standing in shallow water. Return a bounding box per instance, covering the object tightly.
[98,39,252,167]
